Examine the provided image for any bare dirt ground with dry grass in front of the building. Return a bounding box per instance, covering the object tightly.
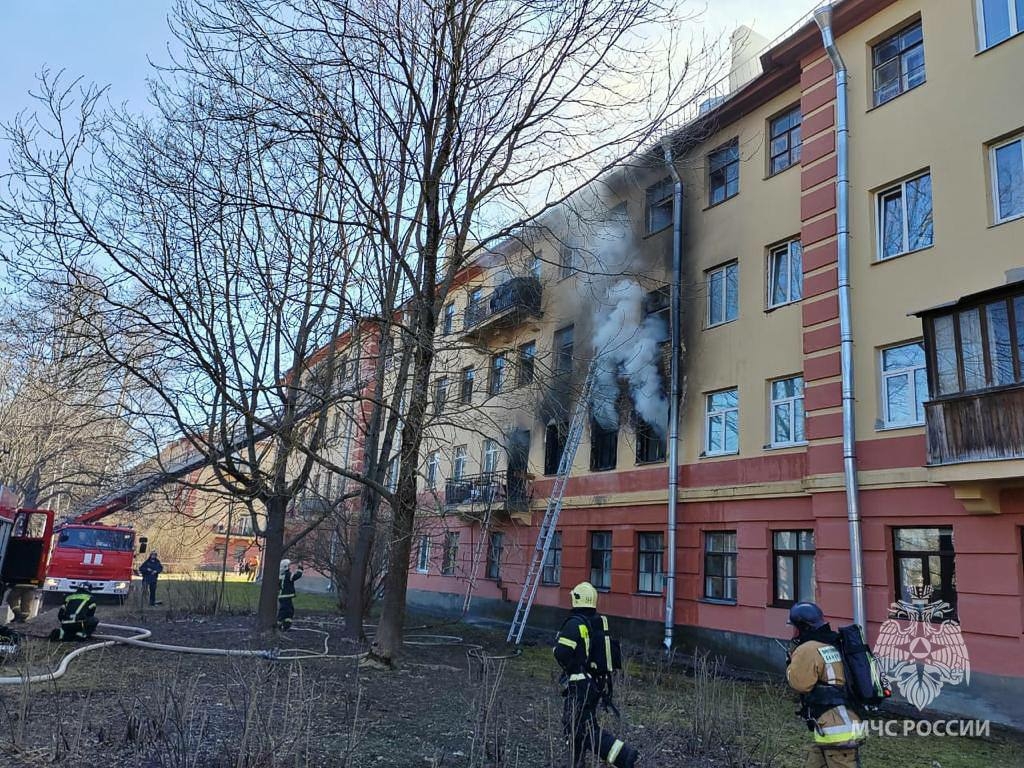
[0,593,1024,768]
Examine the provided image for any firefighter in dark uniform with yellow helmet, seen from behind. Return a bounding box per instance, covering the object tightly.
[553,582,639,768]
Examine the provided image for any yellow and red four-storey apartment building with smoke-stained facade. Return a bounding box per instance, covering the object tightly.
[401,0,1024,721]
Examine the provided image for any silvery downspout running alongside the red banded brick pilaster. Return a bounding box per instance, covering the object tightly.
[814,3,865,627]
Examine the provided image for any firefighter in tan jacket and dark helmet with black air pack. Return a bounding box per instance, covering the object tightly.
[785,602,864,768]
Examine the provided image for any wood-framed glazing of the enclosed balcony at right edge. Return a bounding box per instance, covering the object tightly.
[926,295,1024,397]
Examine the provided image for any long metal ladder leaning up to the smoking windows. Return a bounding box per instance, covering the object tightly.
[506,357,597,645]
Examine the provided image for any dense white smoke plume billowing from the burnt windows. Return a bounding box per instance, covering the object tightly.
[591,280,669,434]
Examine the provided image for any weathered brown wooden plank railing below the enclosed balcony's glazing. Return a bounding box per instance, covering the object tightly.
[925,386,1024,466]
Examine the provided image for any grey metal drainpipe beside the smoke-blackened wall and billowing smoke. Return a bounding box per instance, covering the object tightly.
[662,139,683,652]
